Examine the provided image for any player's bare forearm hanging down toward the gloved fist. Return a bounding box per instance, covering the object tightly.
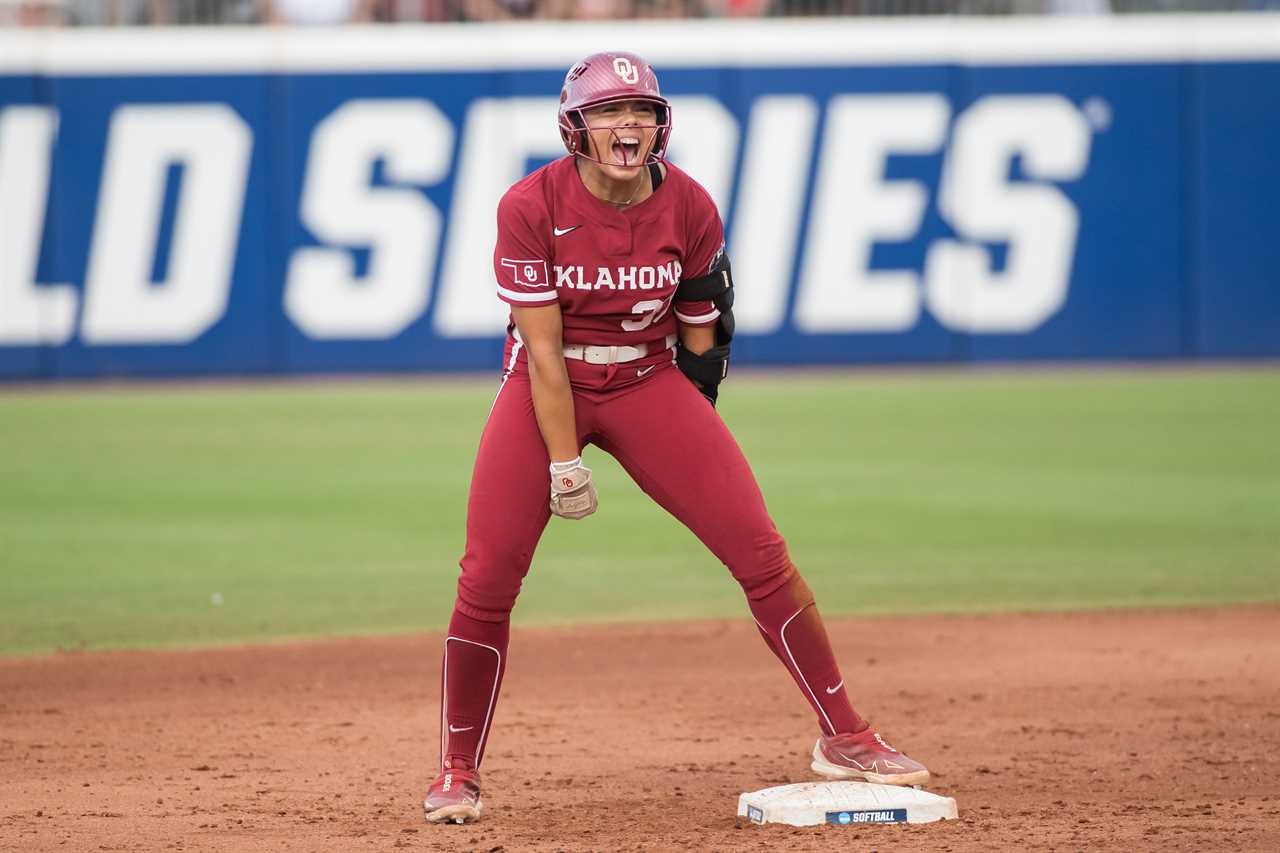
[512,305,580,462]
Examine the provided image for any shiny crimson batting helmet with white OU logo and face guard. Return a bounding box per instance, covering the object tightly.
[559,50,671,164]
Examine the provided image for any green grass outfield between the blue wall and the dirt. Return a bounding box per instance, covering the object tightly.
[0,368,1280,653]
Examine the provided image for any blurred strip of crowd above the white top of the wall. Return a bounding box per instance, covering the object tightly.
[0,0,1280,27]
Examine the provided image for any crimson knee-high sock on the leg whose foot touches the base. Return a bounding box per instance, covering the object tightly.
[748,569,868,735]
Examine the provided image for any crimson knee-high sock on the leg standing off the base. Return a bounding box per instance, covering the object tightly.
[440,607,511,770]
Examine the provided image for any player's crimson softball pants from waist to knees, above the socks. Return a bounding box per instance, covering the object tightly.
[458,366,790,620]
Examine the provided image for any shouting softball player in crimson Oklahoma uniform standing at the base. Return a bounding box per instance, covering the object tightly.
[425,53,929,822]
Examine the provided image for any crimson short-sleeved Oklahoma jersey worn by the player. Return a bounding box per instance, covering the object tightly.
[493,156,724,391]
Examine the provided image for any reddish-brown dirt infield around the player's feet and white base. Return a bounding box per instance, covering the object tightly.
[0,607,1280,853]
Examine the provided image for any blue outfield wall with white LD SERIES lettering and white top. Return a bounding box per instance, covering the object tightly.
[0,15,1280,379]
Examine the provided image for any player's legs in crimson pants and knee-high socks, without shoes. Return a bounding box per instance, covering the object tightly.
[440,364,867,767]
